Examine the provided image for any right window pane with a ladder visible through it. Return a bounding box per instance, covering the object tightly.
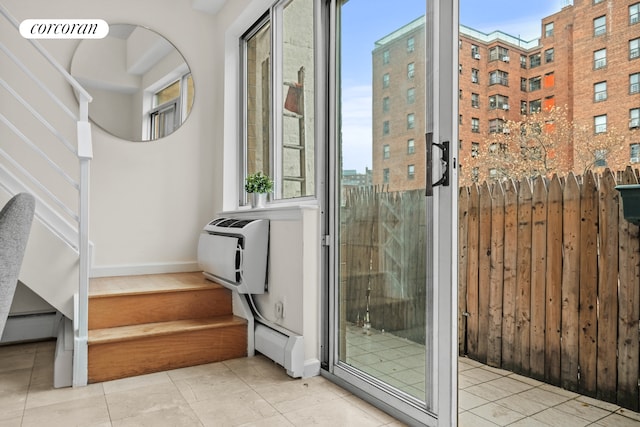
[281,0,315,199]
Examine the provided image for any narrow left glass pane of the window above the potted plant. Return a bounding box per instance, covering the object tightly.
[245,22,271,179]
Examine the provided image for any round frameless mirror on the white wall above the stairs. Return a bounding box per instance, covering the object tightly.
[71,24,195,141]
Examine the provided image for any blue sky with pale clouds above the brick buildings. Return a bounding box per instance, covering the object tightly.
[341,0,569,173]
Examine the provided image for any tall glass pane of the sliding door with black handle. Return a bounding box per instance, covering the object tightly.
[338,0,427,402]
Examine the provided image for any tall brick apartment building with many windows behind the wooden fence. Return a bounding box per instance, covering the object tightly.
[372,0,640,191]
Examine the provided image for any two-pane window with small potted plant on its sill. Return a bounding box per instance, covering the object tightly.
[238,0,316,204]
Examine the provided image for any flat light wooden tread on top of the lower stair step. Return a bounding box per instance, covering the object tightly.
[88,315,247,346]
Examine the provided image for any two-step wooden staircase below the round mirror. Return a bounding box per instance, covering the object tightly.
[88,273,247,383]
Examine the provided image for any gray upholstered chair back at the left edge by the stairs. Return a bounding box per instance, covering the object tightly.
[0,193,36,337]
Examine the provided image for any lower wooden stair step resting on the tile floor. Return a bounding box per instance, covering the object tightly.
[88,315,247,383]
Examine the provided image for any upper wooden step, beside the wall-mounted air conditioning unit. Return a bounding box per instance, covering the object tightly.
[89,273,232,330]
